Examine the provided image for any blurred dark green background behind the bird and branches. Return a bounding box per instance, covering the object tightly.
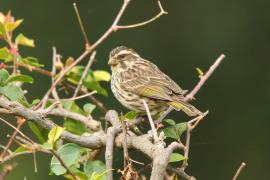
[0,0,270,180]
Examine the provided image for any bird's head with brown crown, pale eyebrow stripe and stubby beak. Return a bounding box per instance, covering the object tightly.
[108,46,140,71]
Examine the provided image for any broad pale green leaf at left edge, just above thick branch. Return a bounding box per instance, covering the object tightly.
[0,84,24,101]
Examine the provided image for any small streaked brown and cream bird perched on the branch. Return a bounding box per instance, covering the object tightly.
[108,46,202,117]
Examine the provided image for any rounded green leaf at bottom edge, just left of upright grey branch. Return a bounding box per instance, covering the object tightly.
[83,160,106,180]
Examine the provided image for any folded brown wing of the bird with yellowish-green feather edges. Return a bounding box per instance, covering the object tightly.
[120,60,184,101]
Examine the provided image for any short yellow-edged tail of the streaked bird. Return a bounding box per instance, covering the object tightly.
[168,100,203,116]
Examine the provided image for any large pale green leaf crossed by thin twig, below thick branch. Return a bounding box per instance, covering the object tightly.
[50,143,82,175]
